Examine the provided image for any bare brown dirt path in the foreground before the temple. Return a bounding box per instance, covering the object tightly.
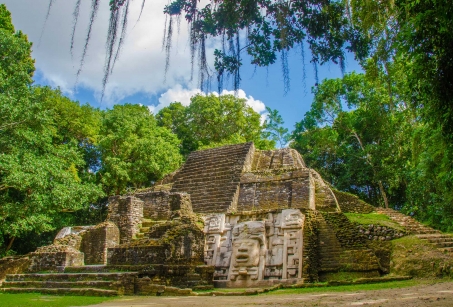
[80,282,453,307]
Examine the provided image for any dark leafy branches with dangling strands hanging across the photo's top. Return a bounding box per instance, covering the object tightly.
[46,0,363,97]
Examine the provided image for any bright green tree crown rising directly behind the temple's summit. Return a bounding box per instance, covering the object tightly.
[156,94,275,155]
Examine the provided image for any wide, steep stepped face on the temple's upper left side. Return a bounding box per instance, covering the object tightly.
[171,143,253,213]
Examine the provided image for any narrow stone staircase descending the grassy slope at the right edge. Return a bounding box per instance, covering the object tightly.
[376,208,453,255]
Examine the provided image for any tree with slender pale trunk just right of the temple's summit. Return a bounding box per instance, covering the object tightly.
[291,73,410,207]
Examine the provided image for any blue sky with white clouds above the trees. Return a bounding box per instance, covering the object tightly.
[2,0,360,131]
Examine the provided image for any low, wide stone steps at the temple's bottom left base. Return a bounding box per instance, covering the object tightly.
[0,274,138,296]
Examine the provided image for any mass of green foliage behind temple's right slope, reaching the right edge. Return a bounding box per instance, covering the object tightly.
[291,58,453,230]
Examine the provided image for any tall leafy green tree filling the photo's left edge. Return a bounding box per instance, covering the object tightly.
[0,5,102,252]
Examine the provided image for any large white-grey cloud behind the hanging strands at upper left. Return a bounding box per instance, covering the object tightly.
[3,0,214,106]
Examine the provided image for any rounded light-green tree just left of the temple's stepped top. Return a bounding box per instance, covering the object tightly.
[97,104,182,195]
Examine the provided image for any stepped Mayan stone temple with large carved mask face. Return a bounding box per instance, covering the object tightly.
[0,143,452,295]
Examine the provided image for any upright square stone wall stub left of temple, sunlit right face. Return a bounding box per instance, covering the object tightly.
[107,196,143,244]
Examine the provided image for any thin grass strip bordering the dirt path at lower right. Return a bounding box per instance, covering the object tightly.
[263,279,436,295]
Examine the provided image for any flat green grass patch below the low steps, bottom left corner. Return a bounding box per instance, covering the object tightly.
[0,293,114,307]
